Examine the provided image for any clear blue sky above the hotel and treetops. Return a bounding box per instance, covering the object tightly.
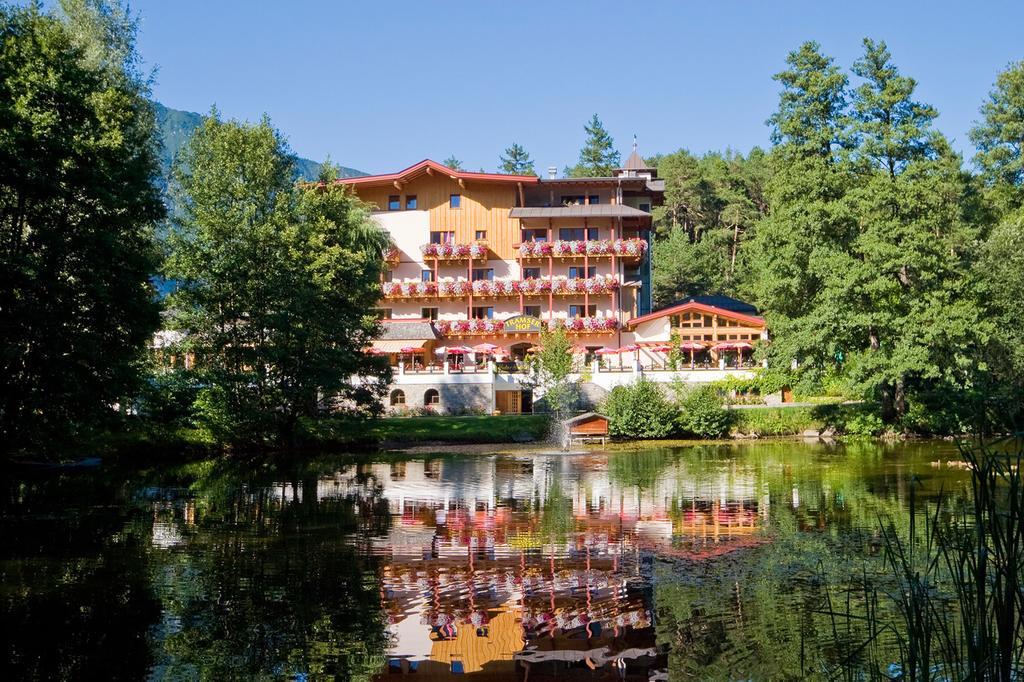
[132,0,1024,172]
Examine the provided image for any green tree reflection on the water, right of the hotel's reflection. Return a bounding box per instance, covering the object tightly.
[654,442,967,679]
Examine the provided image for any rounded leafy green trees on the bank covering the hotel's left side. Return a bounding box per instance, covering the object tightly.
[165,112,389,445]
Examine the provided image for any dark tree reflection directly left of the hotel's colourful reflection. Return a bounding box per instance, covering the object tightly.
[154,454,387,679]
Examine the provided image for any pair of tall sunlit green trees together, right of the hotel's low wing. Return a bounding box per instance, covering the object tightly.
[753,40,991,423]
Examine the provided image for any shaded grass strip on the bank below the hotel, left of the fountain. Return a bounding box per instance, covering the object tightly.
[372,415,549,444]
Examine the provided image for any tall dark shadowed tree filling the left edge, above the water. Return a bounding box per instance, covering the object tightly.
[0,2,164,452]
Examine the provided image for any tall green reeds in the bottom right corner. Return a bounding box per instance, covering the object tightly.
[824,440,1024,682]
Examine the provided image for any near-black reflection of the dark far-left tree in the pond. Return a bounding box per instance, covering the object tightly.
[0,472,160,680]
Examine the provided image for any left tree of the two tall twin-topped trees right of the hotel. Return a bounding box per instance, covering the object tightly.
[751,42,855,369]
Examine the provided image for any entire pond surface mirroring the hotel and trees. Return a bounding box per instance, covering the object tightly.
[0,442,969,680]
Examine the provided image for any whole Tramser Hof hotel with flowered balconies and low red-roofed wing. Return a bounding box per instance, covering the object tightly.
[337,150,767,414]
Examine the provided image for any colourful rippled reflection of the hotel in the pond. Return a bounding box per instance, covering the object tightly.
[268,456,768,679]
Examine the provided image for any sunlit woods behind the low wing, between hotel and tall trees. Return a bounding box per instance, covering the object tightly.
[652,148,769,305]
